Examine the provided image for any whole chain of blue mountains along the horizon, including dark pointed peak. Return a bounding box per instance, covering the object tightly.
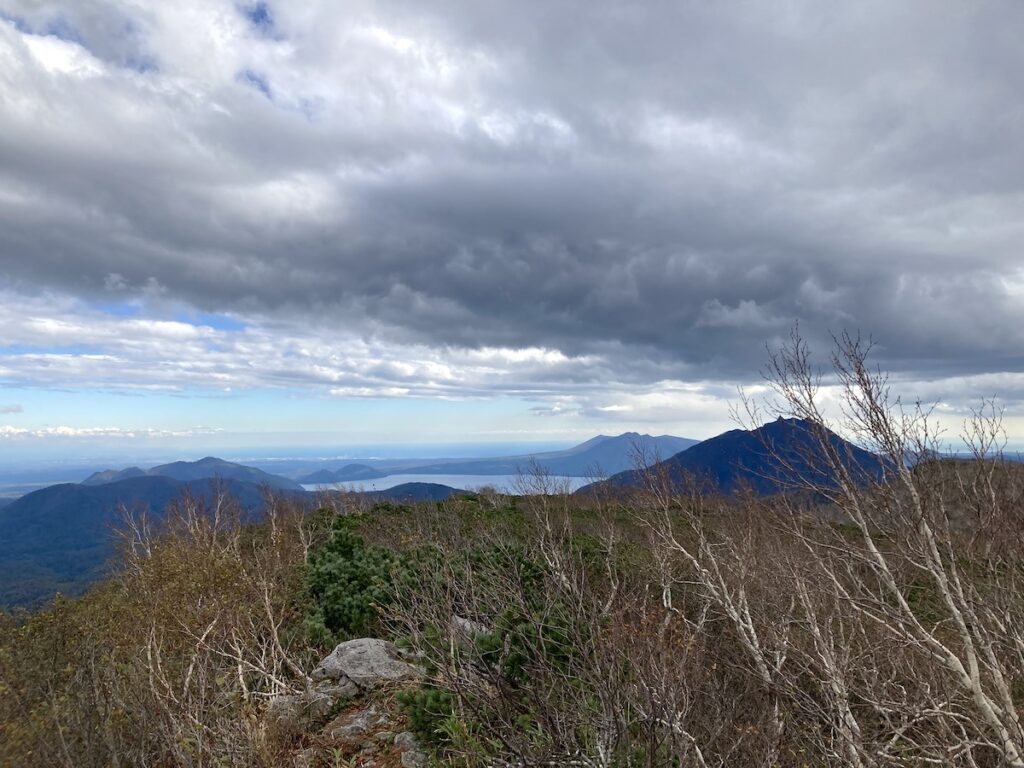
[6,419,884,605]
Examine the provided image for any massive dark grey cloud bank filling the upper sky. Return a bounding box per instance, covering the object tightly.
[0,0,1024,385]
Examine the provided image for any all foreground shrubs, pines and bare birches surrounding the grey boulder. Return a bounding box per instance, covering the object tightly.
[0,339,1024,768]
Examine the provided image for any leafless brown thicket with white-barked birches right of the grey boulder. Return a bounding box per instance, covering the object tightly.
[390,336,1024,766]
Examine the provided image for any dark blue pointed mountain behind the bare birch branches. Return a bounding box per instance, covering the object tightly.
[578,419,885,496]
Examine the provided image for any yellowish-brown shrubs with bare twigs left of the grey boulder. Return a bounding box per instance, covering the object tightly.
[0,487,325,768]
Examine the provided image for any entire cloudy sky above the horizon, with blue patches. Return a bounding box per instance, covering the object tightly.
[0,0,1024,464]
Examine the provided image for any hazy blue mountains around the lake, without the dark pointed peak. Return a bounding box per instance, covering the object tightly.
[0,432,694,605]
